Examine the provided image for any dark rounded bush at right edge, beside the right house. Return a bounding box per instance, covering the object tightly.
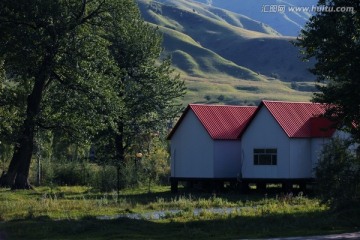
[315,139,360,208]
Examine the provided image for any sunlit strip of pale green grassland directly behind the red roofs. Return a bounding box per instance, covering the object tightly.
[183,75,312,105]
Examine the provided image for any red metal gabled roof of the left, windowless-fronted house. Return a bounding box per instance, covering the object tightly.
[168,104,257,140]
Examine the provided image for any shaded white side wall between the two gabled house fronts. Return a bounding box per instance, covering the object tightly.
[214,140,241,178]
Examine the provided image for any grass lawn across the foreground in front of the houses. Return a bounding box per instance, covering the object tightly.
[0,187,360,239]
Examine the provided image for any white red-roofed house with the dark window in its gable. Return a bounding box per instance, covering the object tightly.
[241,101,335,189]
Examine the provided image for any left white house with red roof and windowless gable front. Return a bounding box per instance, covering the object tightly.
[168,104,257,190]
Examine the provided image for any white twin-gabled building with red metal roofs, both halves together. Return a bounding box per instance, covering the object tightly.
[168,101,335,190]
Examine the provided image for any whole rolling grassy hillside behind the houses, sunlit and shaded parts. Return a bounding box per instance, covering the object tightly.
[138,0,313,104]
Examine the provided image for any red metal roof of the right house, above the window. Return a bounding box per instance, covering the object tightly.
[258,101,335,138]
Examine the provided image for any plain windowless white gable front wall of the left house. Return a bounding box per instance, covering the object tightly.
[171,110,214,178]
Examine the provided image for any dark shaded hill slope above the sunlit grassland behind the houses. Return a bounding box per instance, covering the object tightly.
[221,37,314,82]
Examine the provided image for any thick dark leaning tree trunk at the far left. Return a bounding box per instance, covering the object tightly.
[0,56,52,189]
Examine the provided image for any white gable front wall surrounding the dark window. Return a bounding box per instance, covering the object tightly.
[241,107,291,178]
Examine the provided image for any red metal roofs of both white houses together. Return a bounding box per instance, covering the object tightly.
[168,101,335,140]
